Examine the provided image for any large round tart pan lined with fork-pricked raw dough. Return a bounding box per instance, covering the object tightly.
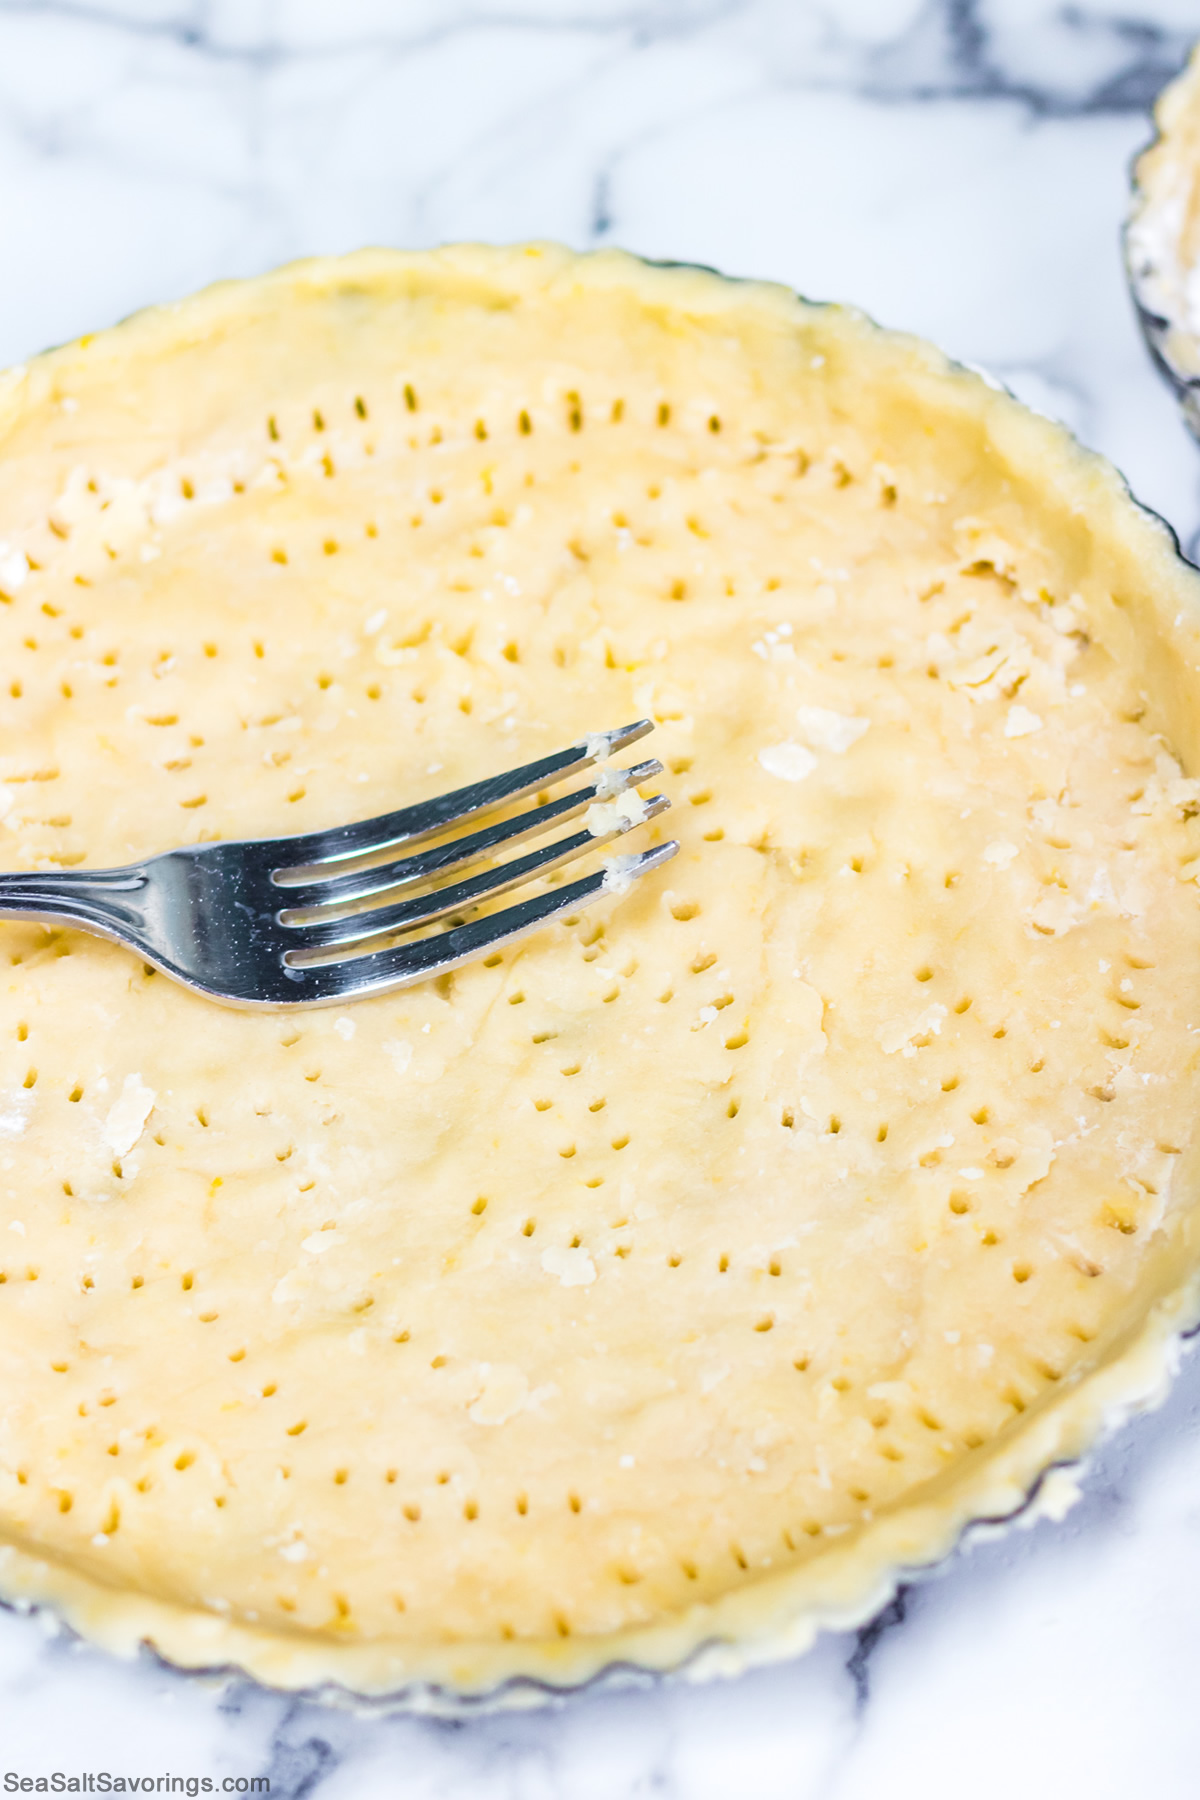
[0,245,1200,1708]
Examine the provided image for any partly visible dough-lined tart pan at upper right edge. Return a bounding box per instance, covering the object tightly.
[1124,39,1200,437]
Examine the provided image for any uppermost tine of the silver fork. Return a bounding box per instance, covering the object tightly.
[272,718,655,886]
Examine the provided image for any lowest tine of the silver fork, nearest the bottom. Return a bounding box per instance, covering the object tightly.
[275,839,678,1006]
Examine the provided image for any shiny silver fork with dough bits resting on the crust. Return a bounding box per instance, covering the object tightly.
[0,718,678,1008]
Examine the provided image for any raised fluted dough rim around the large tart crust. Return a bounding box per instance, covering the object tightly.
[0,247,1200,1714]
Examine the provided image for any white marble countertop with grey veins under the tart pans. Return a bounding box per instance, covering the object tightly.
[0,0,1200,1800]
